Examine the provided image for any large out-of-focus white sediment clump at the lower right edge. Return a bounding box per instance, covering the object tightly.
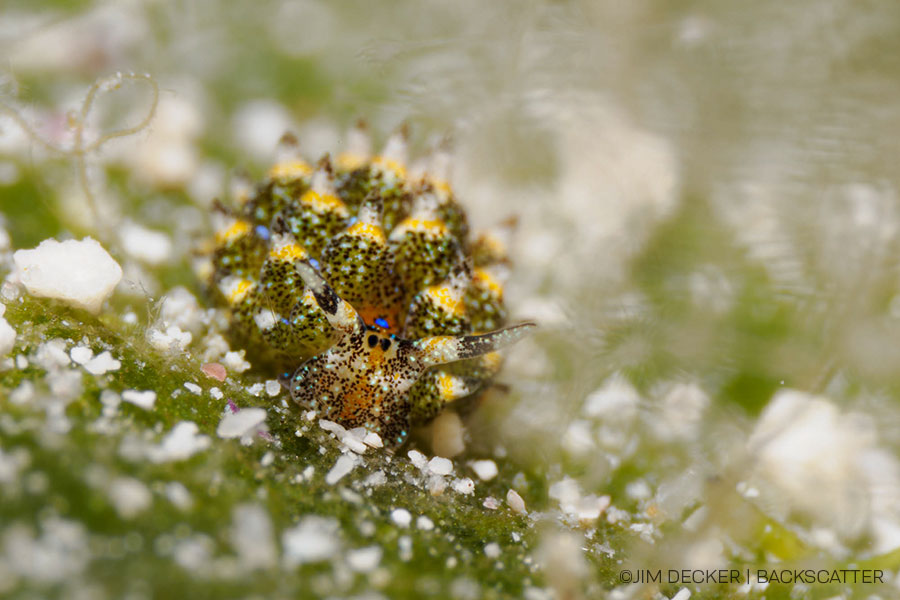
[740,389,900,554]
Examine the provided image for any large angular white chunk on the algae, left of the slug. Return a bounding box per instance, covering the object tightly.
[13,237,122,314]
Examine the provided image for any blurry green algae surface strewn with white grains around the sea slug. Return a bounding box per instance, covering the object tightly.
[0,0,900,600]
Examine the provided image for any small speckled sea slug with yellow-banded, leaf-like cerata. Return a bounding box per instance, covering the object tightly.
[211,128,534,446]
